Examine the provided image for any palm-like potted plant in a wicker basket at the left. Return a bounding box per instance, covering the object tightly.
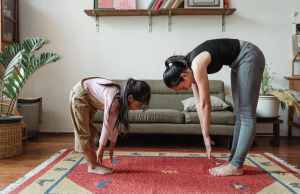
[0,38,60,158]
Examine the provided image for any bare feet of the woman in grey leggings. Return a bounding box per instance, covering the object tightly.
[209,164,244,176]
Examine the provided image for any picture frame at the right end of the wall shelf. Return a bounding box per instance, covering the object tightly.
[184,0,224,9]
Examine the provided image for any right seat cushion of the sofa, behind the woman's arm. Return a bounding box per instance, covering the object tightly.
[184,111,234,125]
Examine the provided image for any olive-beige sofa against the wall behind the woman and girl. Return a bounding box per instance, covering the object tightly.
[94,80,234,136]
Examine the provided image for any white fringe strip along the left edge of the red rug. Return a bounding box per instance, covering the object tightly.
[0,149,68,194]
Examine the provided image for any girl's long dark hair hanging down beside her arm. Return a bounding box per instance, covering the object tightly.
[114,78,151,131]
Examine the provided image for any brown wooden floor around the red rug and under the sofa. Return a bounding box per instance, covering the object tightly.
[0,134,300,190]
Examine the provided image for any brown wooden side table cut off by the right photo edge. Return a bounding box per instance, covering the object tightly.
[285,75,300,137]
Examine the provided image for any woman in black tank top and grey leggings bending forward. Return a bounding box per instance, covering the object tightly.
[163,39,265,176]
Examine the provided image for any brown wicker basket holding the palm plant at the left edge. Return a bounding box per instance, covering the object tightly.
[0,122,23,159]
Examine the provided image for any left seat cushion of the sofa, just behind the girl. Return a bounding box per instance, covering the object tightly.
[94,109,185,123]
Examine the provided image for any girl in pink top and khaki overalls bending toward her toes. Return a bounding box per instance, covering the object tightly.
[70,77,151,174]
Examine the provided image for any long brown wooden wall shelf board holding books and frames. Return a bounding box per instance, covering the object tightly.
[84,8,236,17]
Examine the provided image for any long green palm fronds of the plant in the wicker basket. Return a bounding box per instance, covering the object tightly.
[0,38,60,113]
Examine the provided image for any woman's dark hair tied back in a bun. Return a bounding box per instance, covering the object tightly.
[163,55,190,88]
